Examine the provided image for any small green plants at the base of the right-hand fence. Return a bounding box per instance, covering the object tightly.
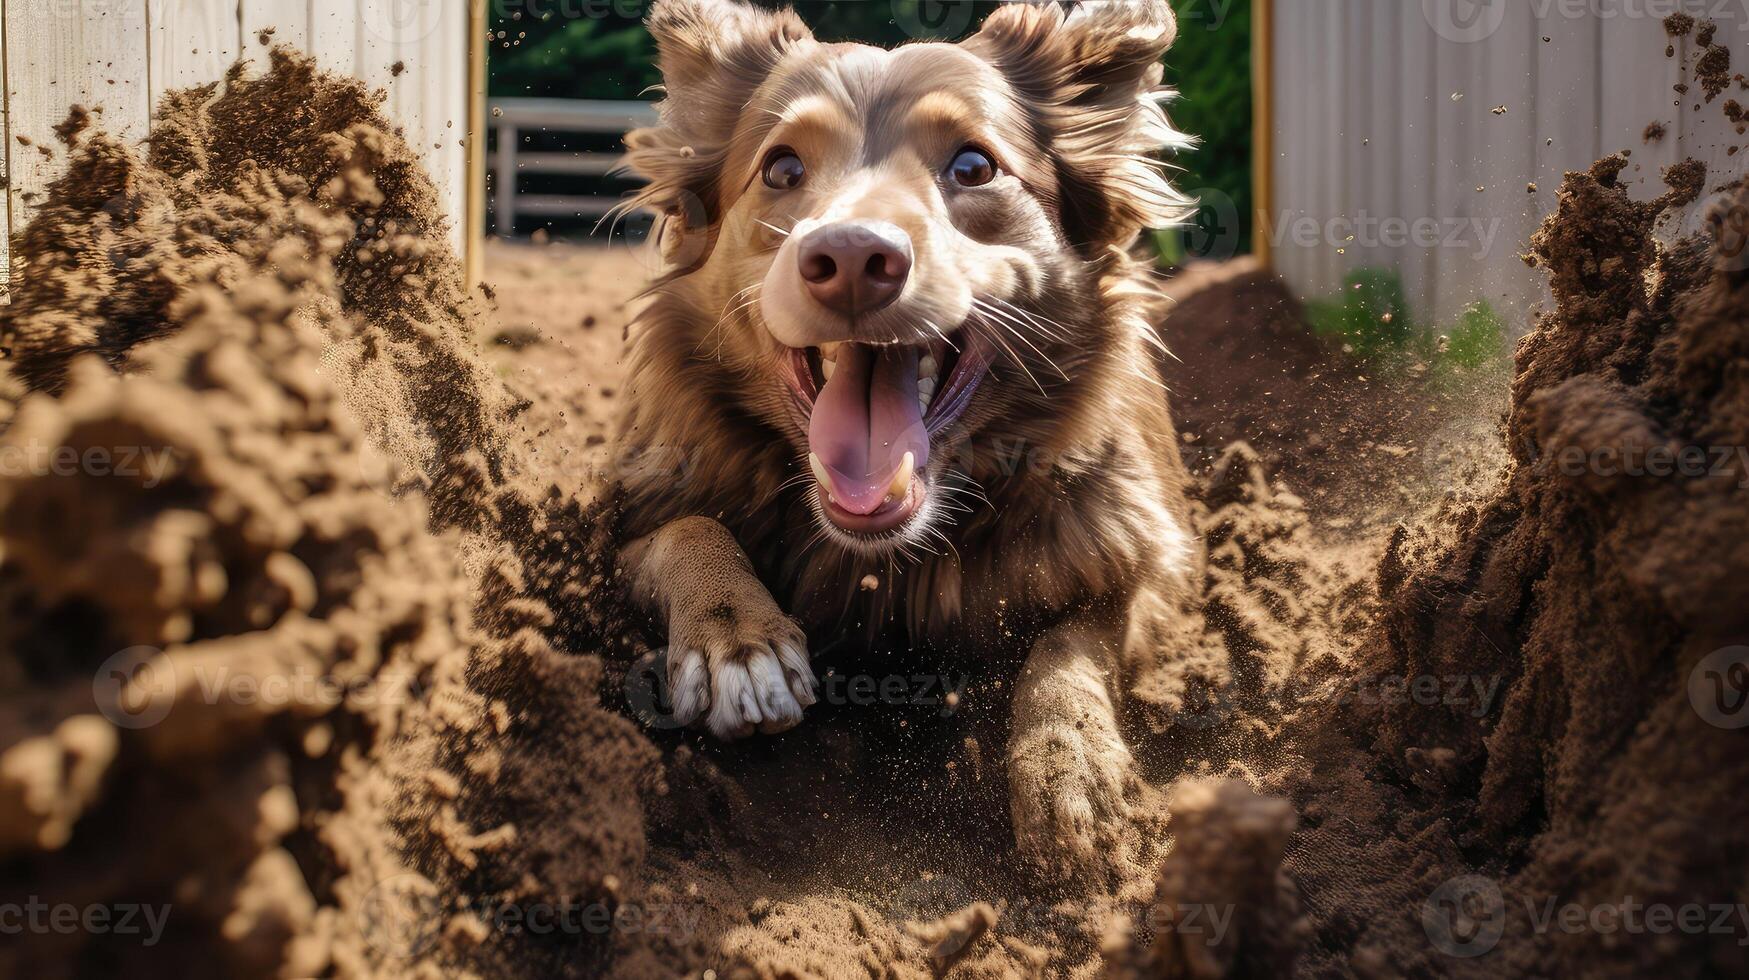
[1307,268,1509,371]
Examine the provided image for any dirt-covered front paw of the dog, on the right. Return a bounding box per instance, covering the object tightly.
[1009,719,1140,884]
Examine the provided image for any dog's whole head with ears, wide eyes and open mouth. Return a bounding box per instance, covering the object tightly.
[630,0,1182,551]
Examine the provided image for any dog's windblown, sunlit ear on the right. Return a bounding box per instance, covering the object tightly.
[965,0,1191,254]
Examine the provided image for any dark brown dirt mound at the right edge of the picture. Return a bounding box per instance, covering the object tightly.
[1259,158,1749,975]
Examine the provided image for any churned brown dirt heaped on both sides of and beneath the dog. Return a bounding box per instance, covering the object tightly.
[0,38,1749,978]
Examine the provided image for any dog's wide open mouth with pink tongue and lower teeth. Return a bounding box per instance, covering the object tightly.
[789,333,990,536]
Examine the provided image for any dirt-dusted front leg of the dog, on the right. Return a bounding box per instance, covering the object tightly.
[1007,616,1139,882]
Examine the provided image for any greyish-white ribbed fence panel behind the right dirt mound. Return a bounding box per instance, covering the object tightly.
[1273,0,1749,326]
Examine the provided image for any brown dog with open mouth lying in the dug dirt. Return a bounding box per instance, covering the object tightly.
[619,0,1195,865]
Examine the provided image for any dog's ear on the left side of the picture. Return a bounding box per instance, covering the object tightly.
[626,0,813,226]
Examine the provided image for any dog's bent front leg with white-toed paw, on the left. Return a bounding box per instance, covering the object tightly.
[619,518,815,739]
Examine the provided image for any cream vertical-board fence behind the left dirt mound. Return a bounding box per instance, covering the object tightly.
[0,0,484,285]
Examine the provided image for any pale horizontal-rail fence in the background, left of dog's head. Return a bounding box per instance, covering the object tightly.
[491,98,656,236]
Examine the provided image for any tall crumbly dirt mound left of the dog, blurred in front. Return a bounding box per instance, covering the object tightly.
[0,51,656,977]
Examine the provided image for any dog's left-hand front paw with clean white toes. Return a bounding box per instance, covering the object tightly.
[668,579,819,739]
